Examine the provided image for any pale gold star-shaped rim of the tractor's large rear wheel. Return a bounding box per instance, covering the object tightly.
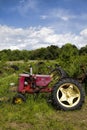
[57,83,80,108]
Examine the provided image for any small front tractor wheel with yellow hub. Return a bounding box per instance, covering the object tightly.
[12,93,26,104]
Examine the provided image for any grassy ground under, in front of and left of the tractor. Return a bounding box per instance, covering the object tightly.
[0,61,87,130]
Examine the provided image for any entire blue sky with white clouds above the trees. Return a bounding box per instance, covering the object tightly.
[0,0,87,50]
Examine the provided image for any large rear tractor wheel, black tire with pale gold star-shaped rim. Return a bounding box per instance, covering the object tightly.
[52,78,85,111]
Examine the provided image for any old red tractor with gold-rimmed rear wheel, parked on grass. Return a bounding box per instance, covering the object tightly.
[13,65,85,110]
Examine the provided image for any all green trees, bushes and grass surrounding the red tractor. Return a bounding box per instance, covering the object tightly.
[0,44,87,130]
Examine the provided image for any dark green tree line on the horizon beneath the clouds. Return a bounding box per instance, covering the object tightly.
[0,43,87,62]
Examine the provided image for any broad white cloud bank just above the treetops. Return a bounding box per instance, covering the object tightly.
[0,25,87,50]
